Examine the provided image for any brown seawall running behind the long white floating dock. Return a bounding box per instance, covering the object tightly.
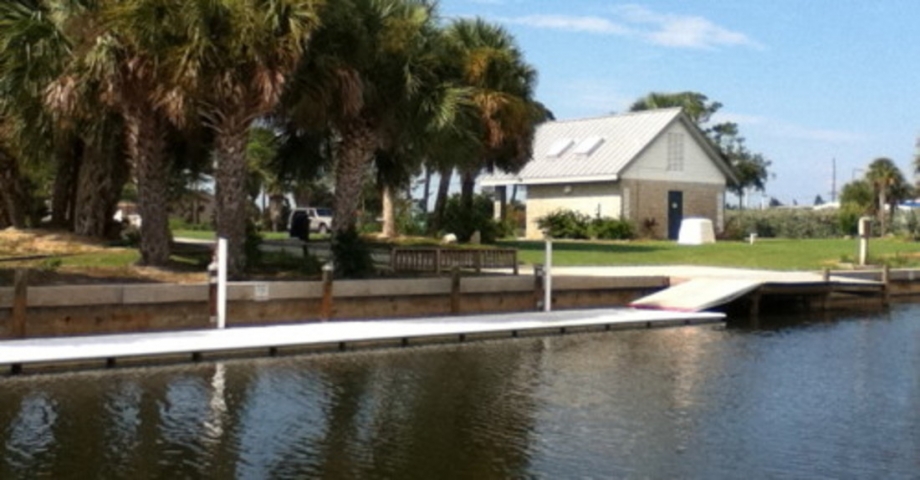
[0,276,669,339]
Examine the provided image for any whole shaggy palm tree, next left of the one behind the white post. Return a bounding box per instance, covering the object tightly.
[48,0,185,266]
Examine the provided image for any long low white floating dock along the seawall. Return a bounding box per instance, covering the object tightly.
[0,308,724,373]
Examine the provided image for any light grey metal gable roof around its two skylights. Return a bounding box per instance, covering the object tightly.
[481,108,681,185]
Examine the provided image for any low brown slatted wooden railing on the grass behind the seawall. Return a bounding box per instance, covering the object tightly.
[390,248,518,275]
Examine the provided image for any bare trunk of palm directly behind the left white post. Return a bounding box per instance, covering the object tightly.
[215,115,249,276]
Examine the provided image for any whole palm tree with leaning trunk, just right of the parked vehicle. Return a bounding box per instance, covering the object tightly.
[285,0,442,246]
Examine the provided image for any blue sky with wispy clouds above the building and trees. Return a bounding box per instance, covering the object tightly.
[440,0,920,204]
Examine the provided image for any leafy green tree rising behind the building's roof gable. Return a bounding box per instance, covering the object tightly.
[630,92,772,206]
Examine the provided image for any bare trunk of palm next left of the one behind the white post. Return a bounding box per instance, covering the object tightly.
[124,107,170,266]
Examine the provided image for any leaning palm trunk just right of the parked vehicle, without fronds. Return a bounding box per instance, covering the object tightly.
[332,122,377,235]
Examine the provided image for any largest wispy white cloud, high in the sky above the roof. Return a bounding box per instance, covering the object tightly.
[505,5,761,49]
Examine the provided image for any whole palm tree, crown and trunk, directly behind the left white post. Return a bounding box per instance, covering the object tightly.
[160,0,322,274]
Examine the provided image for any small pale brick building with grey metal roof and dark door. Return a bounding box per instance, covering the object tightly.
[480,108,737,239]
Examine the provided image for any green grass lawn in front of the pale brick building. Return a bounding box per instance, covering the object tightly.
[501,239,920,270]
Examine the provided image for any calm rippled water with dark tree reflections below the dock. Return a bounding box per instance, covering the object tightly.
[0,305,920,480]
